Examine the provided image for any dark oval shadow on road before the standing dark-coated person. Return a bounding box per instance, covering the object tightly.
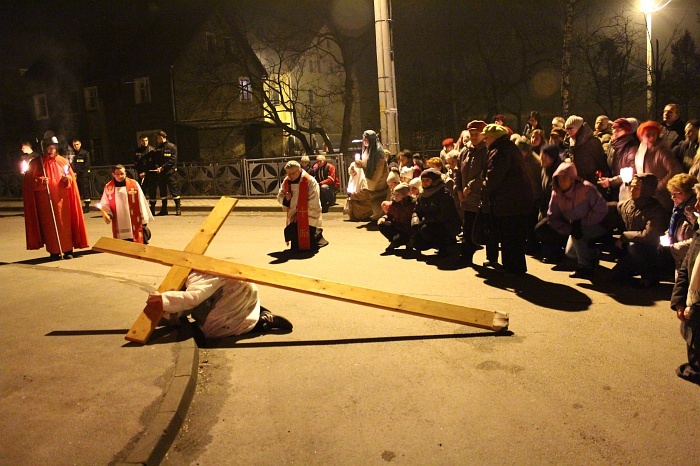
[474,266,593,312]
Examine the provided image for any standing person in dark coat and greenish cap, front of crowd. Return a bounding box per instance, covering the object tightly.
[483,124,534,275]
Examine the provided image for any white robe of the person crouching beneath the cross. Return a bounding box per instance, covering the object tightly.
[162,272,260,338]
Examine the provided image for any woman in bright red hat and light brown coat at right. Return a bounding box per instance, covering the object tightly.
[634,121,683,212]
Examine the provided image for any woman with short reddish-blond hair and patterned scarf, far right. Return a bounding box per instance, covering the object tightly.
[661,173,697,270]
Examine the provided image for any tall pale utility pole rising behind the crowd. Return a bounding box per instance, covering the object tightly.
[374,0,399,155]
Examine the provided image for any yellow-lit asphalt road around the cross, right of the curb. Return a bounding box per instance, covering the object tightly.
[0,210,700,465]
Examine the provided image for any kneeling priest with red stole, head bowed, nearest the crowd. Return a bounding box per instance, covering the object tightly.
[277,160,328,251]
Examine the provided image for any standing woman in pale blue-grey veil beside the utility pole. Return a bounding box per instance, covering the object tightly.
[355,130,389,221]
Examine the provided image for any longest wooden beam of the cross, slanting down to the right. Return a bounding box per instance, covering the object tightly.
[93,237,508,331]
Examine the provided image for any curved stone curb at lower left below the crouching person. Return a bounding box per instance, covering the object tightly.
[117,338,199,466]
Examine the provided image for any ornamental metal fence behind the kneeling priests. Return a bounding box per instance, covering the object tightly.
[0,154,353,199]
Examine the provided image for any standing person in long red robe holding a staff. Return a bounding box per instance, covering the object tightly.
[22,137,90,260]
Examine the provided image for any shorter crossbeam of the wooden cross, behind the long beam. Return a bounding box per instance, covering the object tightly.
[115,197,238,345]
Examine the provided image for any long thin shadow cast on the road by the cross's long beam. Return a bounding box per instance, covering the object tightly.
[207,330,513,348]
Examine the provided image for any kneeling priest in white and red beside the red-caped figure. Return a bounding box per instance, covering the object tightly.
[100,165,153,244]
